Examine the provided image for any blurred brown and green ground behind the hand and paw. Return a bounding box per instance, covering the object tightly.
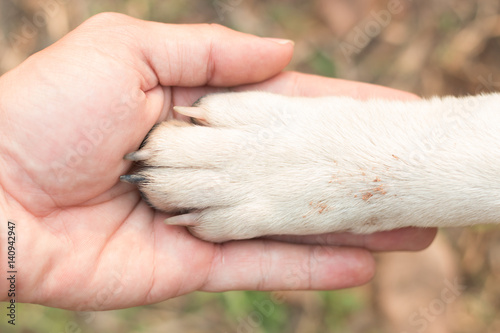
[0,0,500,333]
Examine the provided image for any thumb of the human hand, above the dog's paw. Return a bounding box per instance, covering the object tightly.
[139,22,293,86]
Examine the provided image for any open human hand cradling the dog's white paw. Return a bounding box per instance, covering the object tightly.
[0,13,436,311]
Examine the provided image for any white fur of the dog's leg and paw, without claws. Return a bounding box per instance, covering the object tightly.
[128,92,500,241]
